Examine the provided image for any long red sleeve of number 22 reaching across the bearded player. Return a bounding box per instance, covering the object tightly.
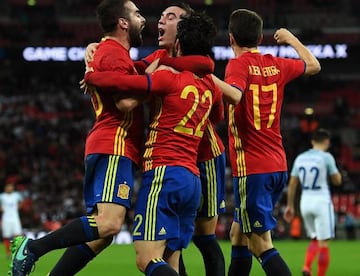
[84,71,150,94]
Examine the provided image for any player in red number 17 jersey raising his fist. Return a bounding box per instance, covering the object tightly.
[225,9,320,276]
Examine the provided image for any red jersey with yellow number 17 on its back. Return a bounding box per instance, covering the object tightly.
[225,51,305,177]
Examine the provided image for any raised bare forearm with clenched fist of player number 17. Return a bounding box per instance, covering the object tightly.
[274,28,321,75]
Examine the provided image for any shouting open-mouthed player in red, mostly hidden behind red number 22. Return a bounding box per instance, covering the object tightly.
[86,2,226,276]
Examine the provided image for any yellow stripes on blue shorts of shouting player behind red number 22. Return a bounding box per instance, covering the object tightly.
[205,159,217,216]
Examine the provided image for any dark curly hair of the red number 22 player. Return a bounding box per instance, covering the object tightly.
[176,13,216,56]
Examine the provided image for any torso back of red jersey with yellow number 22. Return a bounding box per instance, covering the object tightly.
[144,70,222,174]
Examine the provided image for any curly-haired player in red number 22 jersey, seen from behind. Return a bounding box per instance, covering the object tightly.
[85,11,241,275]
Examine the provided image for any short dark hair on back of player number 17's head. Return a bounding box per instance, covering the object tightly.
[229,9,263,48]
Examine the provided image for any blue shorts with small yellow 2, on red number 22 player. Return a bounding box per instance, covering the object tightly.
[133,166,201,251]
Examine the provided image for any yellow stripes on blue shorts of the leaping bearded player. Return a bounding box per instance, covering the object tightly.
[101,155,120,202]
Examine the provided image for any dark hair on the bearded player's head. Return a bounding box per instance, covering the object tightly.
[96,0,129,33]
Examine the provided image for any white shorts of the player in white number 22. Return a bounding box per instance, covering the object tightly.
[300,197,335,240]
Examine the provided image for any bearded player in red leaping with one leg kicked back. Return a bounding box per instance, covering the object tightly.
[10,0,145,276]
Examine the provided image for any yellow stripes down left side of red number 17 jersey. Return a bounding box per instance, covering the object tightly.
[229,104,246,177]
